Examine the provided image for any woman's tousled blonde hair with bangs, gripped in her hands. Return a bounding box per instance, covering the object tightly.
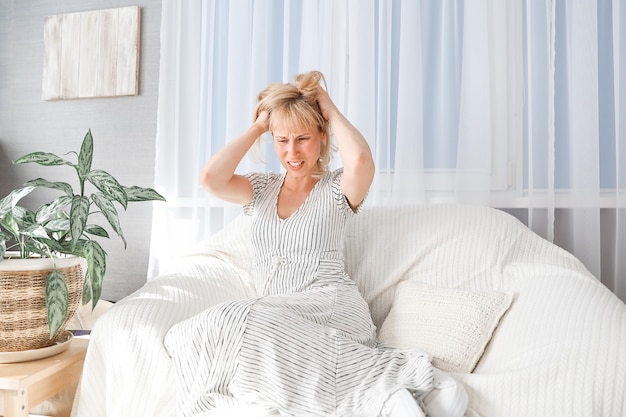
[254,71,332,177]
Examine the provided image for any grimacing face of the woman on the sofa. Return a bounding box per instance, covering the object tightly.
[272,122,325,176]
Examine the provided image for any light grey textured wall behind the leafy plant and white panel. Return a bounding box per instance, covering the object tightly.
[0,0,161,301]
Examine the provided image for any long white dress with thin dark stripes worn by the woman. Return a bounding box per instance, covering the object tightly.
[166,169,432,417]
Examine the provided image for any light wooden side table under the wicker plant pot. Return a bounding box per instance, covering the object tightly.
[0,338,89,417]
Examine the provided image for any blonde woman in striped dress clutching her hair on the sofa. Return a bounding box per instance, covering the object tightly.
[166,71,467,417]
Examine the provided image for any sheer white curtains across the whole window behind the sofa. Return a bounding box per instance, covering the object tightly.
[149,0,626,298]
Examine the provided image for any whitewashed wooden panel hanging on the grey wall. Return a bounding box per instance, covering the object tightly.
[42,6,141,100]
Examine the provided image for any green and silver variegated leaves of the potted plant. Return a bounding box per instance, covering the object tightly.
[0,130,165,350]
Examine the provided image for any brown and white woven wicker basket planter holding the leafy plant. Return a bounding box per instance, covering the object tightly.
[0,257,83,352]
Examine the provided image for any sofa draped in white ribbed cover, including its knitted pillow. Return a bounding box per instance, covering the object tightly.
[72,204,626,417]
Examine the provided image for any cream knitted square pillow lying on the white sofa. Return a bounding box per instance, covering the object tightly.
[378,281,513,373]
